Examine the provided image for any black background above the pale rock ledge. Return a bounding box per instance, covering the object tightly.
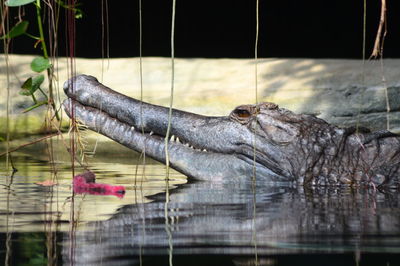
[3,0,400,58]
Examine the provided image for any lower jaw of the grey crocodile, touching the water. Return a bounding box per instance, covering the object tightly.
[63,99,279,182]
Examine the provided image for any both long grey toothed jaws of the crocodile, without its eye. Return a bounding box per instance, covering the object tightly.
[64,75,287,181]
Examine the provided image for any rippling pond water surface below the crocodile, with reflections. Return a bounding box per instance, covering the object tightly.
[0,135,400,265]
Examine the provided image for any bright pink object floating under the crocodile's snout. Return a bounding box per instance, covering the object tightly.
[73,172,125,198]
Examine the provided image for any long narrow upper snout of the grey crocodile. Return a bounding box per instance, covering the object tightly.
[64,75,239,153]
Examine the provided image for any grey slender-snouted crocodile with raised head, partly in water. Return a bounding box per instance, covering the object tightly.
[63,75,400,188]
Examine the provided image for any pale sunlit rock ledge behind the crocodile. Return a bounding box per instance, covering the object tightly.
[0,55,400,138]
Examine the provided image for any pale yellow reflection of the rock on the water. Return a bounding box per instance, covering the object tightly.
[0,157,186,232]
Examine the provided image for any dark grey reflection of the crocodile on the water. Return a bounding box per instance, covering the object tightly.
[64,182,400,265]
